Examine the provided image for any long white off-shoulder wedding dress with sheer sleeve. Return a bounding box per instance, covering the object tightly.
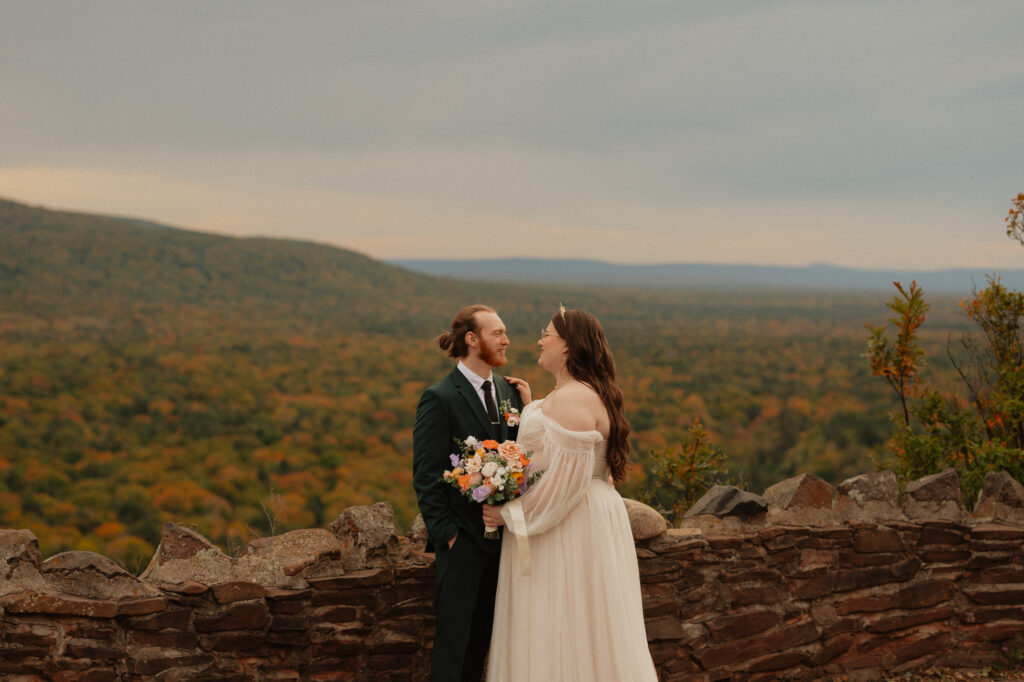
[487,400,657,682]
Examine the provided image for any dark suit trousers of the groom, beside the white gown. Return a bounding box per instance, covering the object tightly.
[430,532,501,682]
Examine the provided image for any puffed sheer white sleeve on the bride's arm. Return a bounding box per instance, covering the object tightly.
[501,419,601,536]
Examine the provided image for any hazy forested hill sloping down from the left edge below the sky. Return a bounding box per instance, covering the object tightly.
[0,200,468,327]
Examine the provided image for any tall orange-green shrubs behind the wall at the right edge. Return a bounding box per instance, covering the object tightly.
[867,194,1024,499]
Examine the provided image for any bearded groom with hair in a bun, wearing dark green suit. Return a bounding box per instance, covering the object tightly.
[413,305,522,682]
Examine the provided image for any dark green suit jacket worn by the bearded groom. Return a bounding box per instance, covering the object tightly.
[413,367,522,552]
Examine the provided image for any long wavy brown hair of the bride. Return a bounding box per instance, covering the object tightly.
[551,310,630,481]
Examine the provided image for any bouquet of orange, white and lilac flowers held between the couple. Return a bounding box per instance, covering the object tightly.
[442,436,542,540]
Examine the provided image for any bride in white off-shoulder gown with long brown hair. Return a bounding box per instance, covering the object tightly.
[483,308,657,682]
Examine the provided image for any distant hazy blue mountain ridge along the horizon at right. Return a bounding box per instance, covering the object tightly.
[389,254,1024,295]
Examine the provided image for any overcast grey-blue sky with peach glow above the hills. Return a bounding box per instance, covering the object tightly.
[0,0,1024,269]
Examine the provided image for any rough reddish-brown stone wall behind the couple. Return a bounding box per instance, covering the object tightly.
[0,472,1024,681]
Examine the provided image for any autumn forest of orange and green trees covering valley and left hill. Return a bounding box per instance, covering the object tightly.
[0,196,991,570]
